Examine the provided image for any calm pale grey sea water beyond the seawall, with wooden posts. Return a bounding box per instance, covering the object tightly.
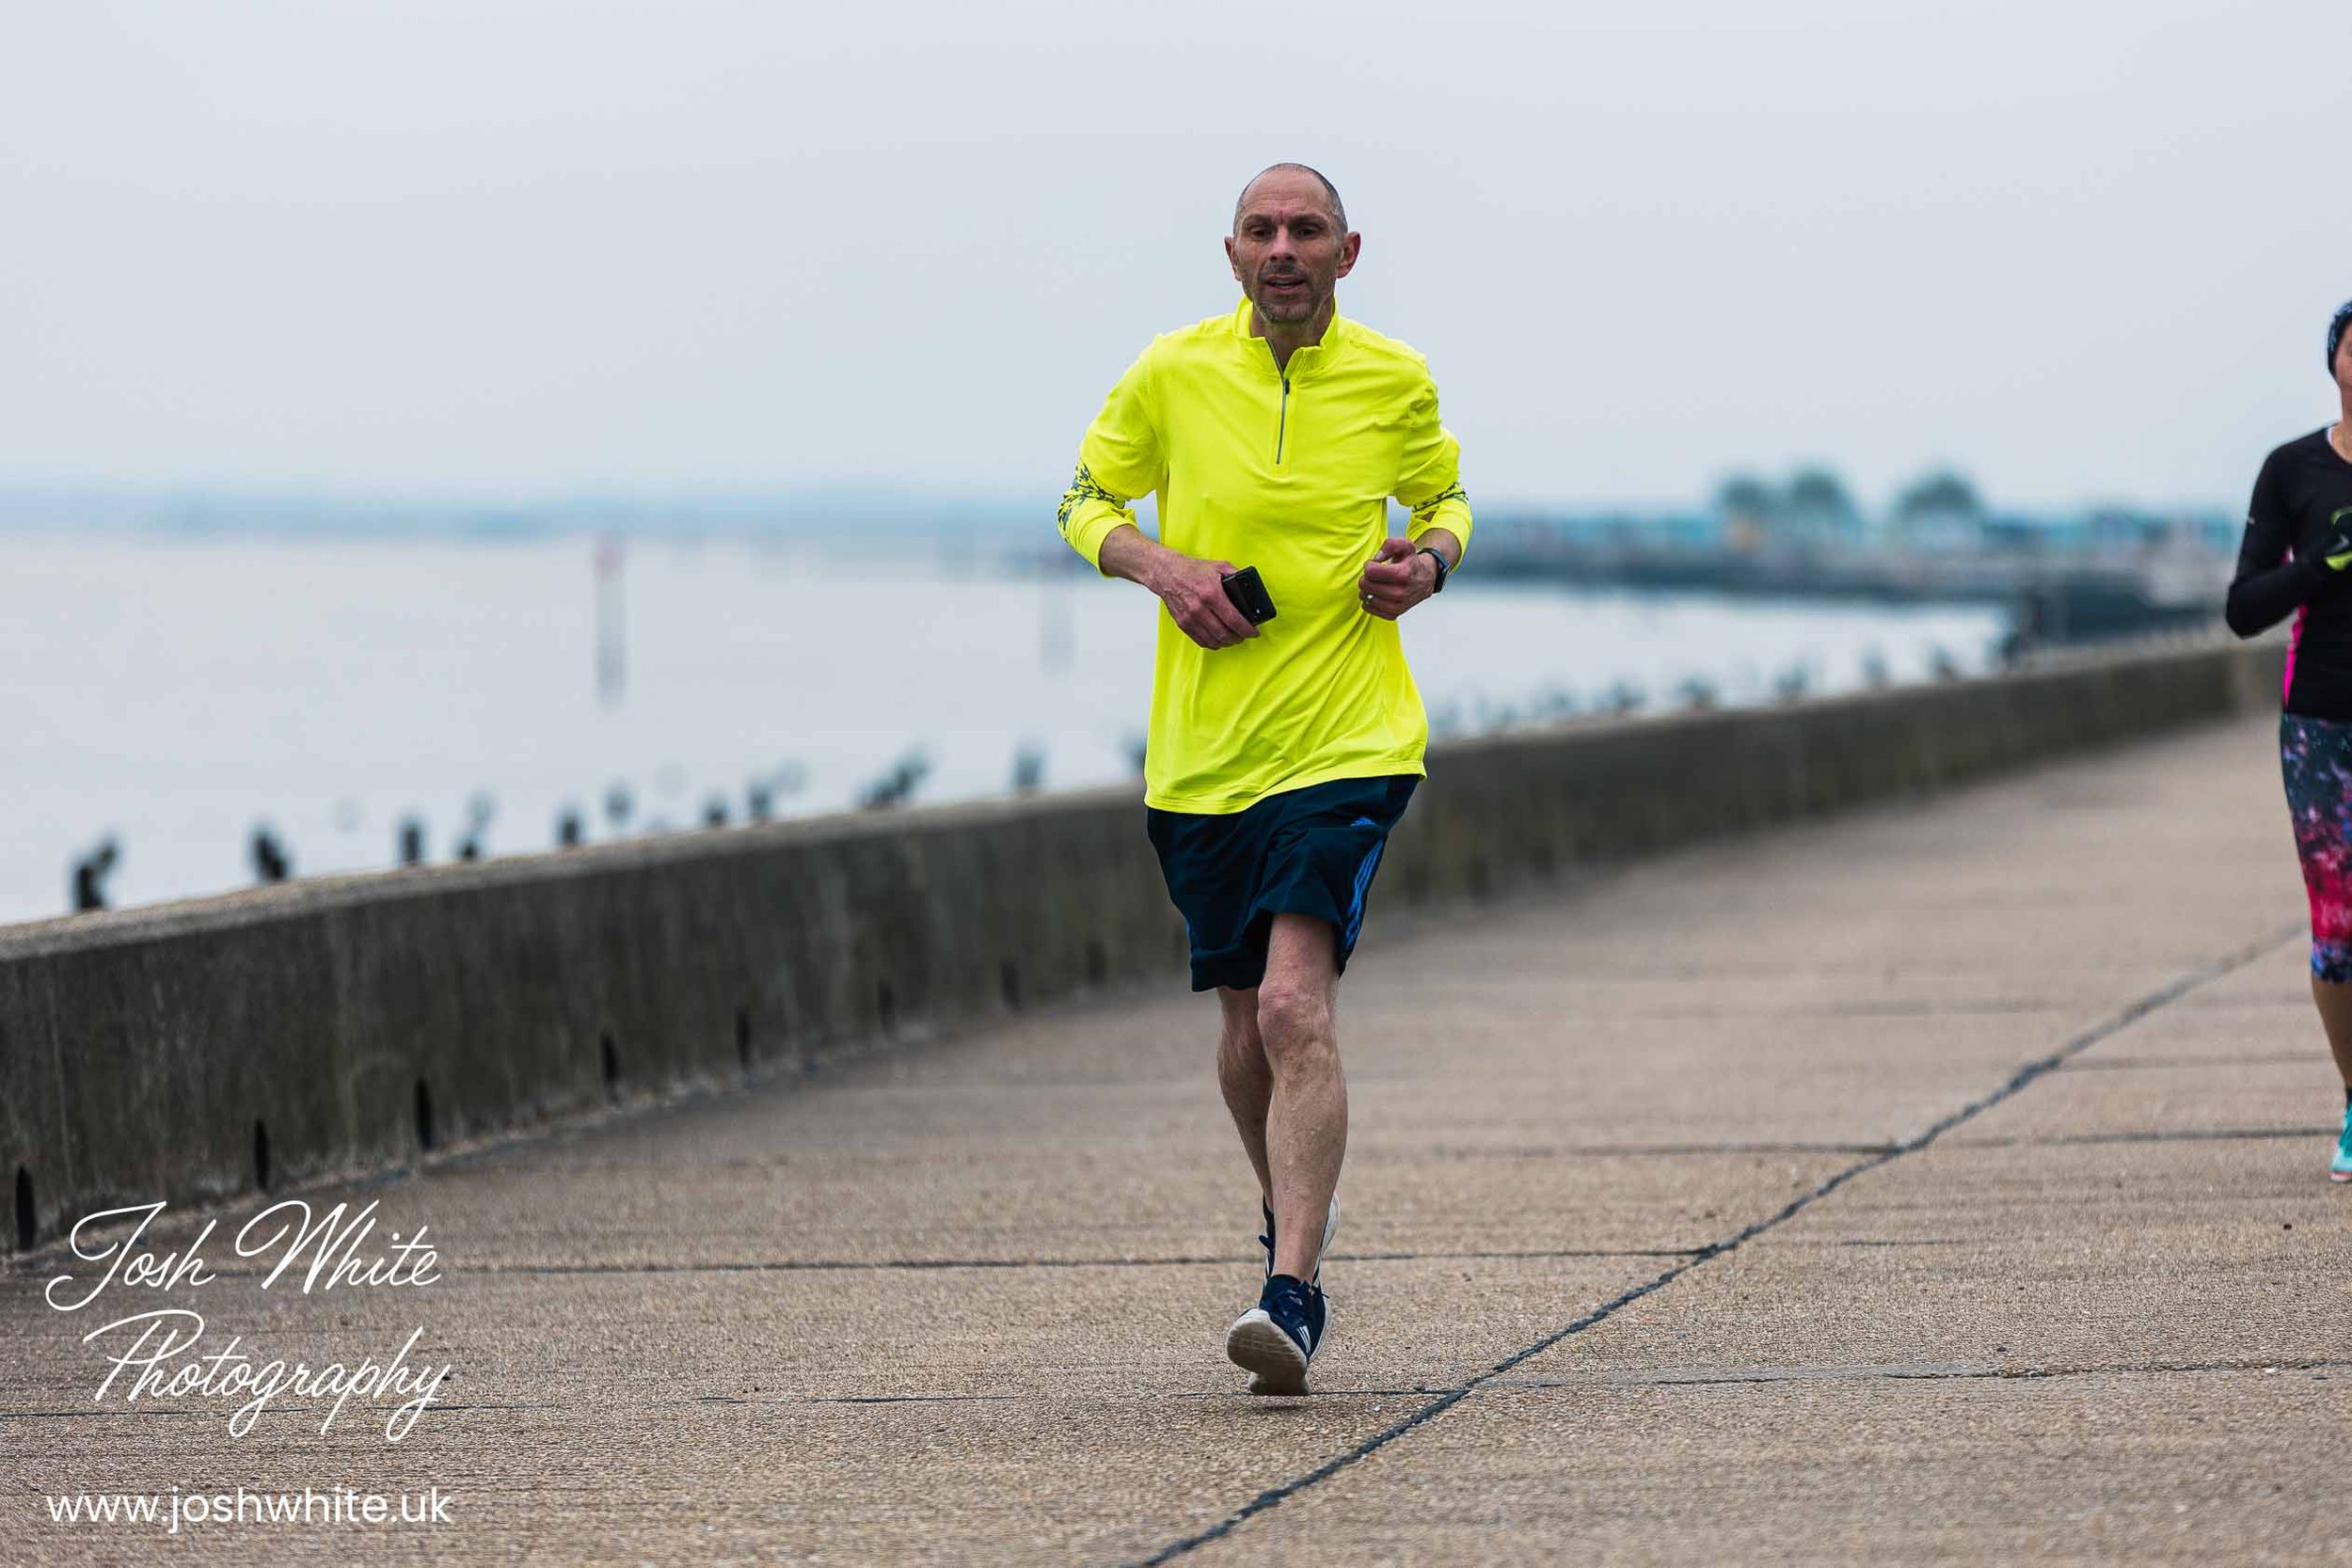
[0,538,2004,922]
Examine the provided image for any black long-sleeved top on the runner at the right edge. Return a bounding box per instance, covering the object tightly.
[2223,428,2352,721]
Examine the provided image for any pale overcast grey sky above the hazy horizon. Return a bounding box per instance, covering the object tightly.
[0,0,2352,508]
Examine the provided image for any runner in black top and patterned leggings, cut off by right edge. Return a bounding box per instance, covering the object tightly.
[2228,303,2352,1182]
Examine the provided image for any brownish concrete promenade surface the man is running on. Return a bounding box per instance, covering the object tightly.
[0,720,2352,1568]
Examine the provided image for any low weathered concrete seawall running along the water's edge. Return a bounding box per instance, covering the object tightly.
[0,641,2280,1248]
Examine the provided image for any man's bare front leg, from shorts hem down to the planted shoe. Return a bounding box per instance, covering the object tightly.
[1251,914,1348,1279]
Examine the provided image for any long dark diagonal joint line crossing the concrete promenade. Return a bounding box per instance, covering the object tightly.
[1132,922,2305,1568]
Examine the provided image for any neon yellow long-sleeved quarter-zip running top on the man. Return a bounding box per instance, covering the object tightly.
[1061,298,1470,814]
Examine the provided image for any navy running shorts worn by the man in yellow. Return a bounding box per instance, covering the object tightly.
[1146,776,1421,992]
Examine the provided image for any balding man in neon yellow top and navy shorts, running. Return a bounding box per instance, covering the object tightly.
[1061,165,1470,1394]
